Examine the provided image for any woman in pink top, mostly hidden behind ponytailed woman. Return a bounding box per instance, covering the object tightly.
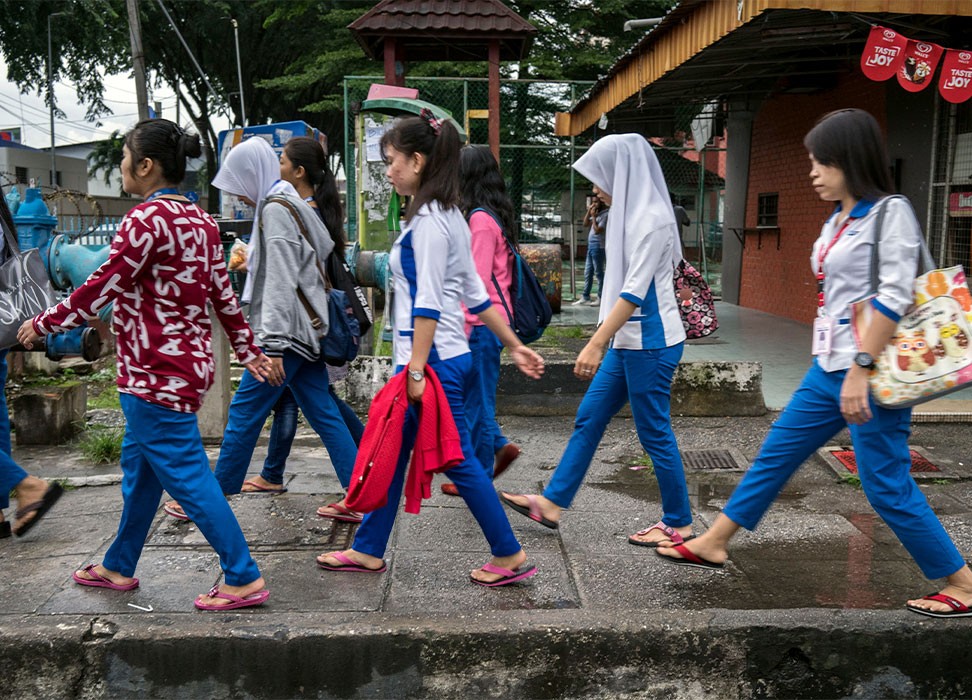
[442,146,520,496]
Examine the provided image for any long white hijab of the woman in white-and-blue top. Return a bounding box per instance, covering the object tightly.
[574,134,682,266]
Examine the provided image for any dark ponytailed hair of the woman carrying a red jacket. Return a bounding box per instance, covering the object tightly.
[381,117,461,219]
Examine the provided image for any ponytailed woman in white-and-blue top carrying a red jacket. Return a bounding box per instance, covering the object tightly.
[317,110,543,586]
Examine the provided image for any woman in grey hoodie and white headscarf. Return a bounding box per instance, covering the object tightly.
[166,137,357,518]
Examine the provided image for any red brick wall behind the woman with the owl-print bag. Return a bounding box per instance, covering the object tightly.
[729,73,886,323]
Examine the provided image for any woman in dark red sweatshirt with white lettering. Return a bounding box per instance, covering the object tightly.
[18,119,270,610]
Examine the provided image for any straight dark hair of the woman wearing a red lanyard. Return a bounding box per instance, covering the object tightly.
[803,109,894,200]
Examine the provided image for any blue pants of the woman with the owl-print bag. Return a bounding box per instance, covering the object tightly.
[723,362,965,578]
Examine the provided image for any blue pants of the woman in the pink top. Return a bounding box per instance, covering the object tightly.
[465,326,509,478]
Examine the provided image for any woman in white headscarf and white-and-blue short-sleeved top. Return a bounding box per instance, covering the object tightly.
[501,134,692,547]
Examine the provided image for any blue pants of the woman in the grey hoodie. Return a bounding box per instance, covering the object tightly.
[216,352,357,494]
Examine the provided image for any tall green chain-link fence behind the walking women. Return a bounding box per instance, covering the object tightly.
[344,76,725,294]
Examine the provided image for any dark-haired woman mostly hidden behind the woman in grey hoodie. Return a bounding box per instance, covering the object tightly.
[242,136,364,522]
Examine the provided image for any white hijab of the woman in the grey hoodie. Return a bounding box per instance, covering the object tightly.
[213,136,300,304]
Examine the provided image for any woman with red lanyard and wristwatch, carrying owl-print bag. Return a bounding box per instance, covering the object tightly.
[658,109,972,617]
